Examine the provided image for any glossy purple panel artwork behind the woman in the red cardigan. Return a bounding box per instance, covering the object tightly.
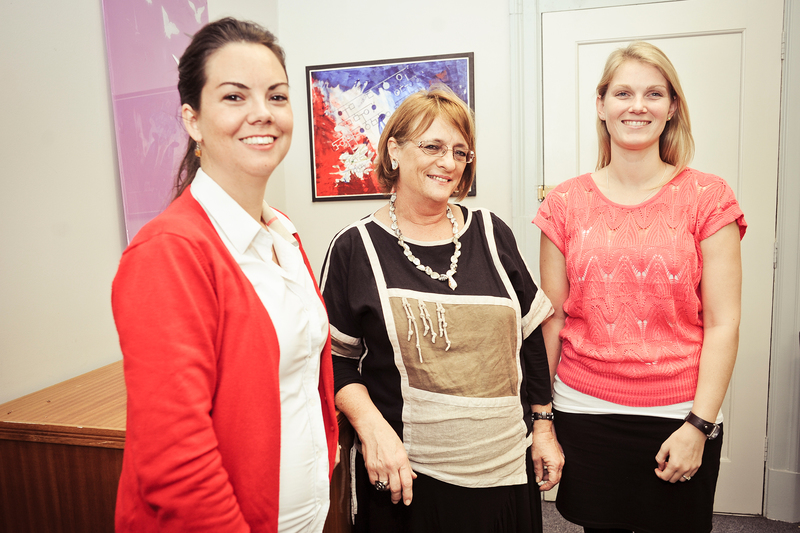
[103,0,208,242]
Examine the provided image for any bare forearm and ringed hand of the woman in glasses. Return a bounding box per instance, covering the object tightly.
[336,383,417,505]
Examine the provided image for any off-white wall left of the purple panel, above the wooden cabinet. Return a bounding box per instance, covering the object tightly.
[0,0,124,402]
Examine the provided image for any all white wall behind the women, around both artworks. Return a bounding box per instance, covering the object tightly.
[0,0,511,403]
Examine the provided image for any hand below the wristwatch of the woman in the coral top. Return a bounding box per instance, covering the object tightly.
[655,422,707,483]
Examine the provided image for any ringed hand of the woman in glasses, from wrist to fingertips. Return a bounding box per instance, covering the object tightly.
[358,417,417,505]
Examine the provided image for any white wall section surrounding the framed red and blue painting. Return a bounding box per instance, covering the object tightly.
[278,0,511,273]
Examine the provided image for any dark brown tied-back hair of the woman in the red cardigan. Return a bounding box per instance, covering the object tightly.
[174,17,286,198]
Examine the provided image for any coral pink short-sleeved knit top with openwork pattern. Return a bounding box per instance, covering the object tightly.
[534,169,747,407]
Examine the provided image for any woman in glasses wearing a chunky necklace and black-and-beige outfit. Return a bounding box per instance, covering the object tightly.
[321,88,563,533]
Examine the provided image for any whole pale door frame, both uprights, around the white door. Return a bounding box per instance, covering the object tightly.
[509,0,800,522]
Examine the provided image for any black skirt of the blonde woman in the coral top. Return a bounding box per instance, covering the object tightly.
[555,412,722,533]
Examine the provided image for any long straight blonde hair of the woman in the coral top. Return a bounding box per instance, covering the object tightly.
[597,41,694,173]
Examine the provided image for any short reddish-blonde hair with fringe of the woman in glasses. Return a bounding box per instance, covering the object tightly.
[375,86,475,200]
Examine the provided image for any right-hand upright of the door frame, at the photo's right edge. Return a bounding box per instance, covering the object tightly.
[764,0,800,522]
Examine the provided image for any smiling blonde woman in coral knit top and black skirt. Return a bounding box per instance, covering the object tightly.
[534,42,746,533]
